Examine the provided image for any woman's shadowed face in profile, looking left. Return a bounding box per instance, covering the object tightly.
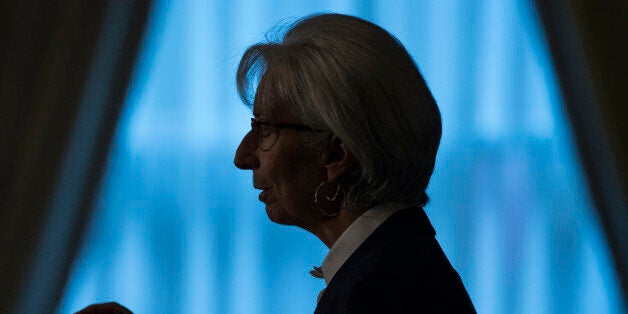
[234,97,327,230]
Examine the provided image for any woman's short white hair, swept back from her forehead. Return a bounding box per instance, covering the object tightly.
[237,14,442,208]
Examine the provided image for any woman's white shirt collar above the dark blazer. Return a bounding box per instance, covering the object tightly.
[315,203,408,285]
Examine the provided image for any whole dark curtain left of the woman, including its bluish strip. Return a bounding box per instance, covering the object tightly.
[0,0,151,313]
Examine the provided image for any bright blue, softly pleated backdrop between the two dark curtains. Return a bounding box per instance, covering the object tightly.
[57,0,625,313]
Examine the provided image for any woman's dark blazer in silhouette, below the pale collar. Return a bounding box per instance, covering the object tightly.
[314,206,476,314]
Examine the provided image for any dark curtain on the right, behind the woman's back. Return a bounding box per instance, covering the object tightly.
[535,0,628,306]
